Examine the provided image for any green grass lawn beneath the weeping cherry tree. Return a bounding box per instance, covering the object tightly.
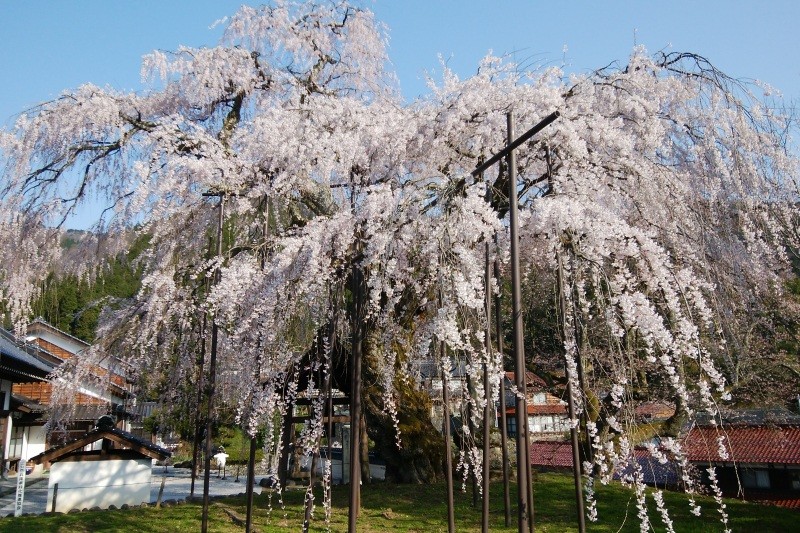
[0,474,800,533]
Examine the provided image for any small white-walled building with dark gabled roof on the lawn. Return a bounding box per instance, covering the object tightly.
[30,417,171,512]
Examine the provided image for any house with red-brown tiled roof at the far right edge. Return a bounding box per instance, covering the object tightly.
[683,410,800,508]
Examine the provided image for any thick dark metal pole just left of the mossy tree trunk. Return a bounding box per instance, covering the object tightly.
[347,265,363,533]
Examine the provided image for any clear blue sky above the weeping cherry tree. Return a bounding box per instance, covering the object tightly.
[0,0,800,125]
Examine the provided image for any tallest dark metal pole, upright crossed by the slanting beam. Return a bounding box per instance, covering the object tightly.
[510,112,536,533]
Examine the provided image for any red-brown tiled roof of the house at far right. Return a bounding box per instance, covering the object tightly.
[683,426,800,465]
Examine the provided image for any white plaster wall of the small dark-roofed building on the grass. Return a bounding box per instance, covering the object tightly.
[47,458,152,513]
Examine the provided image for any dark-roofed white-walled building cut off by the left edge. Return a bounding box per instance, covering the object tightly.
[0,328,53,475]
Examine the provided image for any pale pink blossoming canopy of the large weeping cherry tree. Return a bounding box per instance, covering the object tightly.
[0,1,799,519]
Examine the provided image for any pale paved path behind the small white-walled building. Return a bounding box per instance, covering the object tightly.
[0,466,261,517]
